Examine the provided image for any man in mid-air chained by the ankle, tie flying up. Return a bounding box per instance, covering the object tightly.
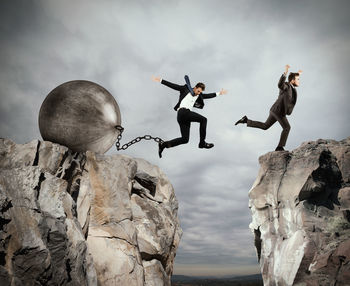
[152,77,227,158]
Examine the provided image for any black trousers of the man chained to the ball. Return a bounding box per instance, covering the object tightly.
[165,108,207,148]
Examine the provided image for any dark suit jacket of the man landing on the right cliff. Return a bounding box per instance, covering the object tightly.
[270,74,297,117]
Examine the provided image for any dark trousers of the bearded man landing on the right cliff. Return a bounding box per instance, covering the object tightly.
[247,111,290,147]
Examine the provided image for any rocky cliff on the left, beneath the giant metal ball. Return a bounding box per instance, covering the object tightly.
[0,139,182,285]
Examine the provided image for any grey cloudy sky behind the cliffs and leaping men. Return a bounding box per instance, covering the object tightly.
[0,0,350,275]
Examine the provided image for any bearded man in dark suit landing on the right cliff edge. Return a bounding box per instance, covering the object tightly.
[235,65,302,151]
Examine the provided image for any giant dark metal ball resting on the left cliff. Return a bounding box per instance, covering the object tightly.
[39,80,121,153]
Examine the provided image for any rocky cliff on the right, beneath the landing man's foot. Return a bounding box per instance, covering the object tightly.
[249,137,350,286]
